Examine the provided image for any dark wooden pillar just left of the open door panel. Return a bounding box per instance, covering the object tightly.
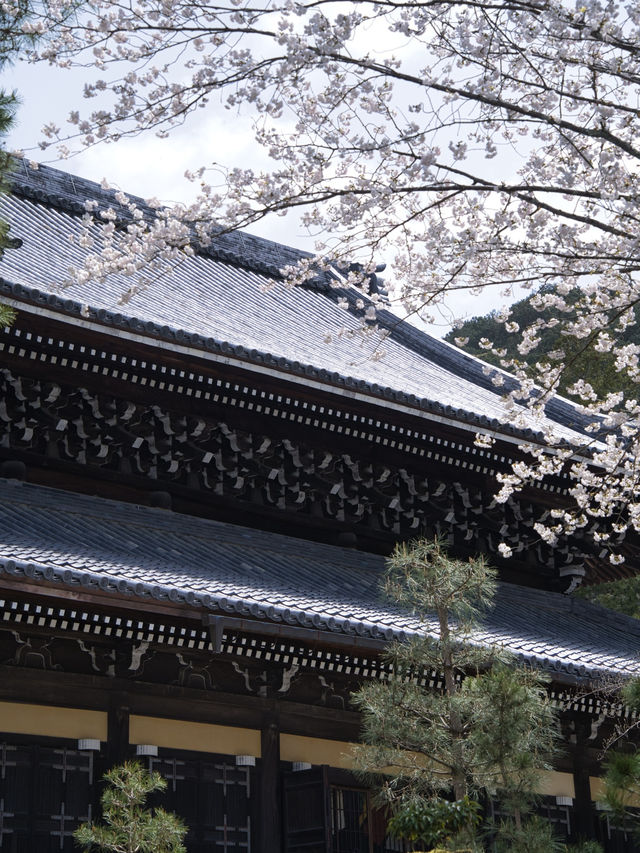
[258,714,282,853]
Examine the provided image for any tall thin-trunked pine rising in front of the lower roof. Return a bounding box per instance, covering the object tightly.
[354,540,556,853]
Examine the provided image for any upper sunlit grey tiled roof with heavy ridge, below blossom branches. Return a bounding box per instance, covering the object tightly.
[0,161,581,446]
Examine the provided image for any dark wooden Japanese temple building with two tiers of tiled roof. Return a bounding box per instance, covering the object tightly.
[0,161,640,853]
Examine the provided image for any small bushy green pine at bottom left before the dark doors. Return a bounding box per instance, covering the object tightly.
[74,761,187,853]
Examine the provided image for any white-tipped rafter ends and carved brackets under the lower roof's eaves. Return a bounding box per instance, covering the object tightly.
[0,628,627,724]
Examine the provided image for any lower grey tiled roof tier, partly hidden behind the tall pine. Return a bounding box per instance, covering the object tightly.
[0,480,640,680]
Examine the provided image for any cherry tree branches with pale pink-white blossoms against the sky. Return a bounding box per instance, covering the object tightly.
[16,0,640,562]
